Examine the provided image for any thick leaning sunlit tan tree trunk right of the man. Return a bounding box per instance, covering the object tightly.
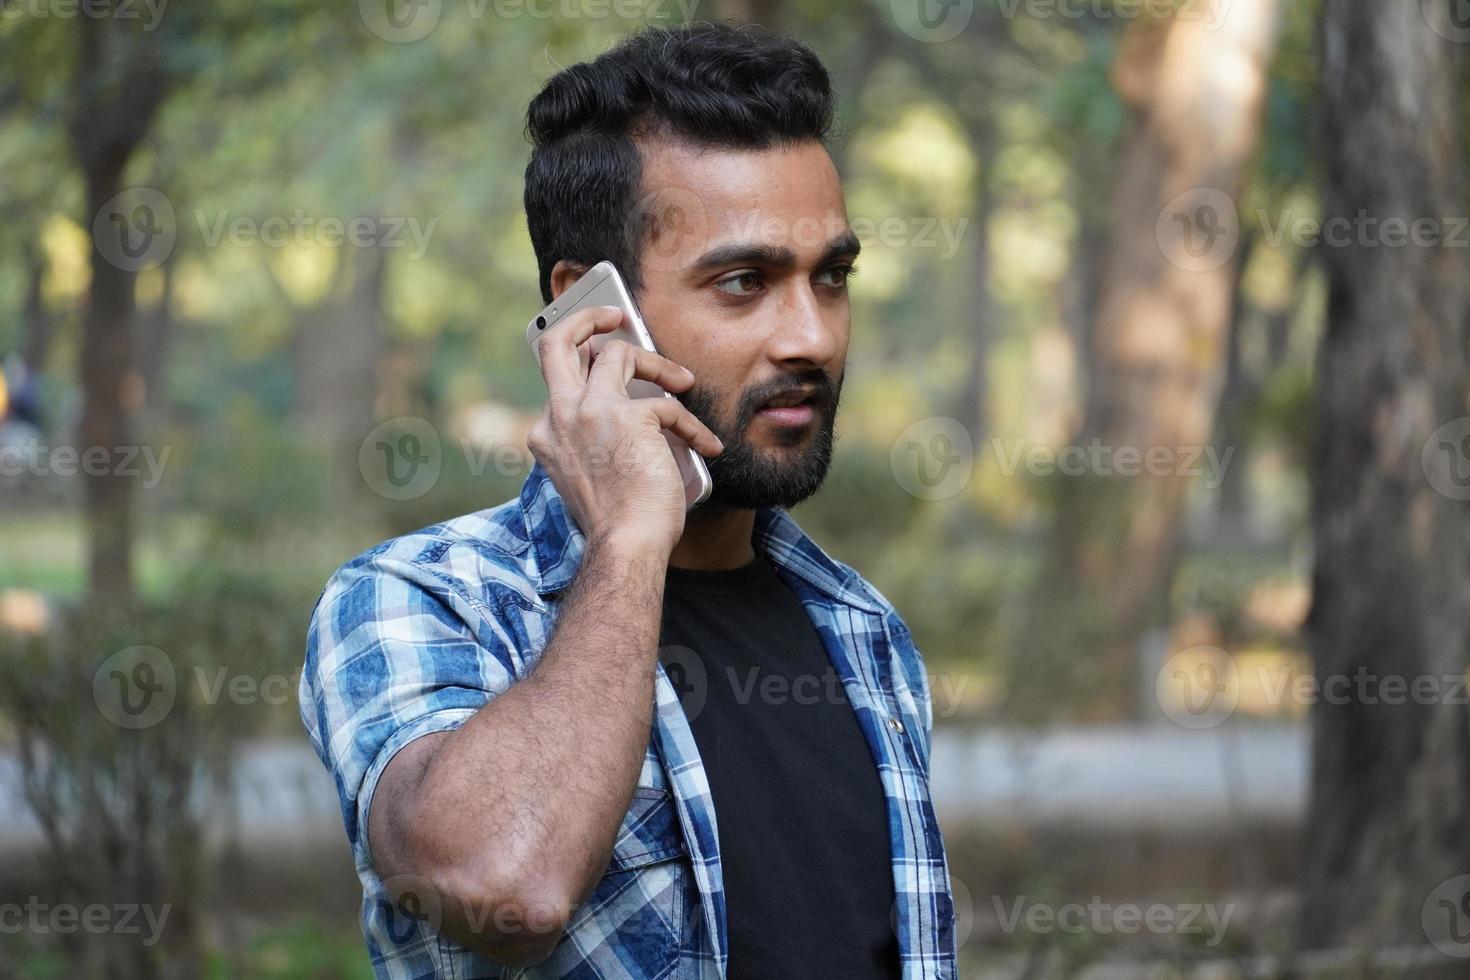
[1014,0,1277,718]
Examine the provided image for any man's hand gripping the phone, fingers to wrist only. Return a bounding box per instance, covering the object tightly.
[526,307,725,554]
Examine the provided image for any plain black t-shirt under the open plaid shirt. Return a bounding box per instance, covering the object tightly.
[660,543,900,980]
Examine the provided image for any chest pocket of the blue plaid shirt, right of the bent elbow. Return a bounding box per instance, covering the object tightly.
[526,786,692,980]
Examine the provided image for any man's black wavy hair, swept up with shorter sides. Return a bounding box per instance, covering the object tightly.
[525,24,833,303]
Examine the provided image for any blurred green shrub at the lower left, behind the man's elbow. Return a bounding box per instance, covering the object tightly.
[0,576,300,977]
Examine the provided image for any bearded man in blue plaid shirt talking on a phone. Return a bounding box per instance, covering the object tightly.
[301,25,954,980]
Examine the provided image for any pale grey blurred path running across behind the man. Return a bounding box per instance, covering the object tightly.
[0,723,1308,848]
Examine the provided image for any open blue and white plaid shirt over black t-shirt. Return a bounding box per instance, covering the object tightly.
[300,464,956,980]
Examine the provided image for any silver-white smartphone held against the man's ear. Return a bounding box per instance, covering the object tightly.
[526,262,714,510]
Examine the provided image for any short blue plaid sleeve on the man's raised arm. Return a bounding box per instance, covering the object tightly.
[298,552,515,867]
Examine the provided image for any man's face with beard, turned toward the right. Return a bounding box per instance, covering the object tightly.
[638,141,858,508]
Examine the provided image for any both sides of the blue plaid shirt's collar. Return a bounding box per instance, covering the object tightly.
[520,463,883,614]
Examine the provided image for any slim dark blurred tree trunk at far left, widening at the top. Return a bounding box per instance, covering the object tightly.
[68,16,169,602]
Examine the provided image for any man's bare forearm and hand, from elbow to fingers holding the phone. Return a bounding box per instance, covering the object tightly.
[368,307,722,965]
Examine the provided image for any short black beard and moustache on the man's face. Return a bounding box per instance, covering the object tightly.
[679,370,842,510]
